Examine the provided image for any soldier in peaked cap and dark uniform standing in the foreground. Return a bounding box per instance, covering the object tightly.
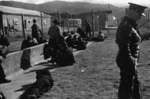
[116,3,147,99]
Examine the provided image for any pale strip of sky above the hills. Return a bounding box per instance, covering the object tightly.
[0,0,150,7]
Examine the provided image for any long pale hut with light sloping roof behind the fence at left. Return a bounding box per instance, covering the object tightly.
[0,5,51,37]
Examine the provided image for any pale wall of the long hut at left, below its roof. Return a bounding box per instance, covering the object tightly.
[2,14,51,37]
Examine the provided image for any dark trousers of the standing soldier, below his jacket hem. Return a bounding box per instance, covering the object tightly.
[118,70,142,99]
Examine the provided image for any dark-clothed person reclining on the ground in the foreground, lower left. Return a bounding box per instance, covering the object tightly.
[20,70,54,99]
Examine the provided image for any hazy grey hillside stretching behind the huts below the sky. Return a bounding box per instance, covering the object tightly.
[0,1,125,18]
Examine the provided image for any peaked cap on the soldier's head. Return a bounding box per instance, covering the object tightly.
[129,2,147,16]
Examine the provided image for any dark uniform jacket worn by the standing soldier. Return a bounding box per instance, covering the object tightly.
[116,16,141,69]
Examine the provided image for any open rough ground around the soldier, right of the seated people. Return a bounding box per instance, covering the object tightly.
[35,31,150,99]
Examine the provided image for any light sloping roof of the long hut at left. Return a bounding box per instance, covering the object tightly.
[0,5,40,16]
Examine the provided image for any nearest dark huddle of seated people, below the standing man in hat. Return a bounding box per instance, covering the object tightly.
[44,36,75,66]
